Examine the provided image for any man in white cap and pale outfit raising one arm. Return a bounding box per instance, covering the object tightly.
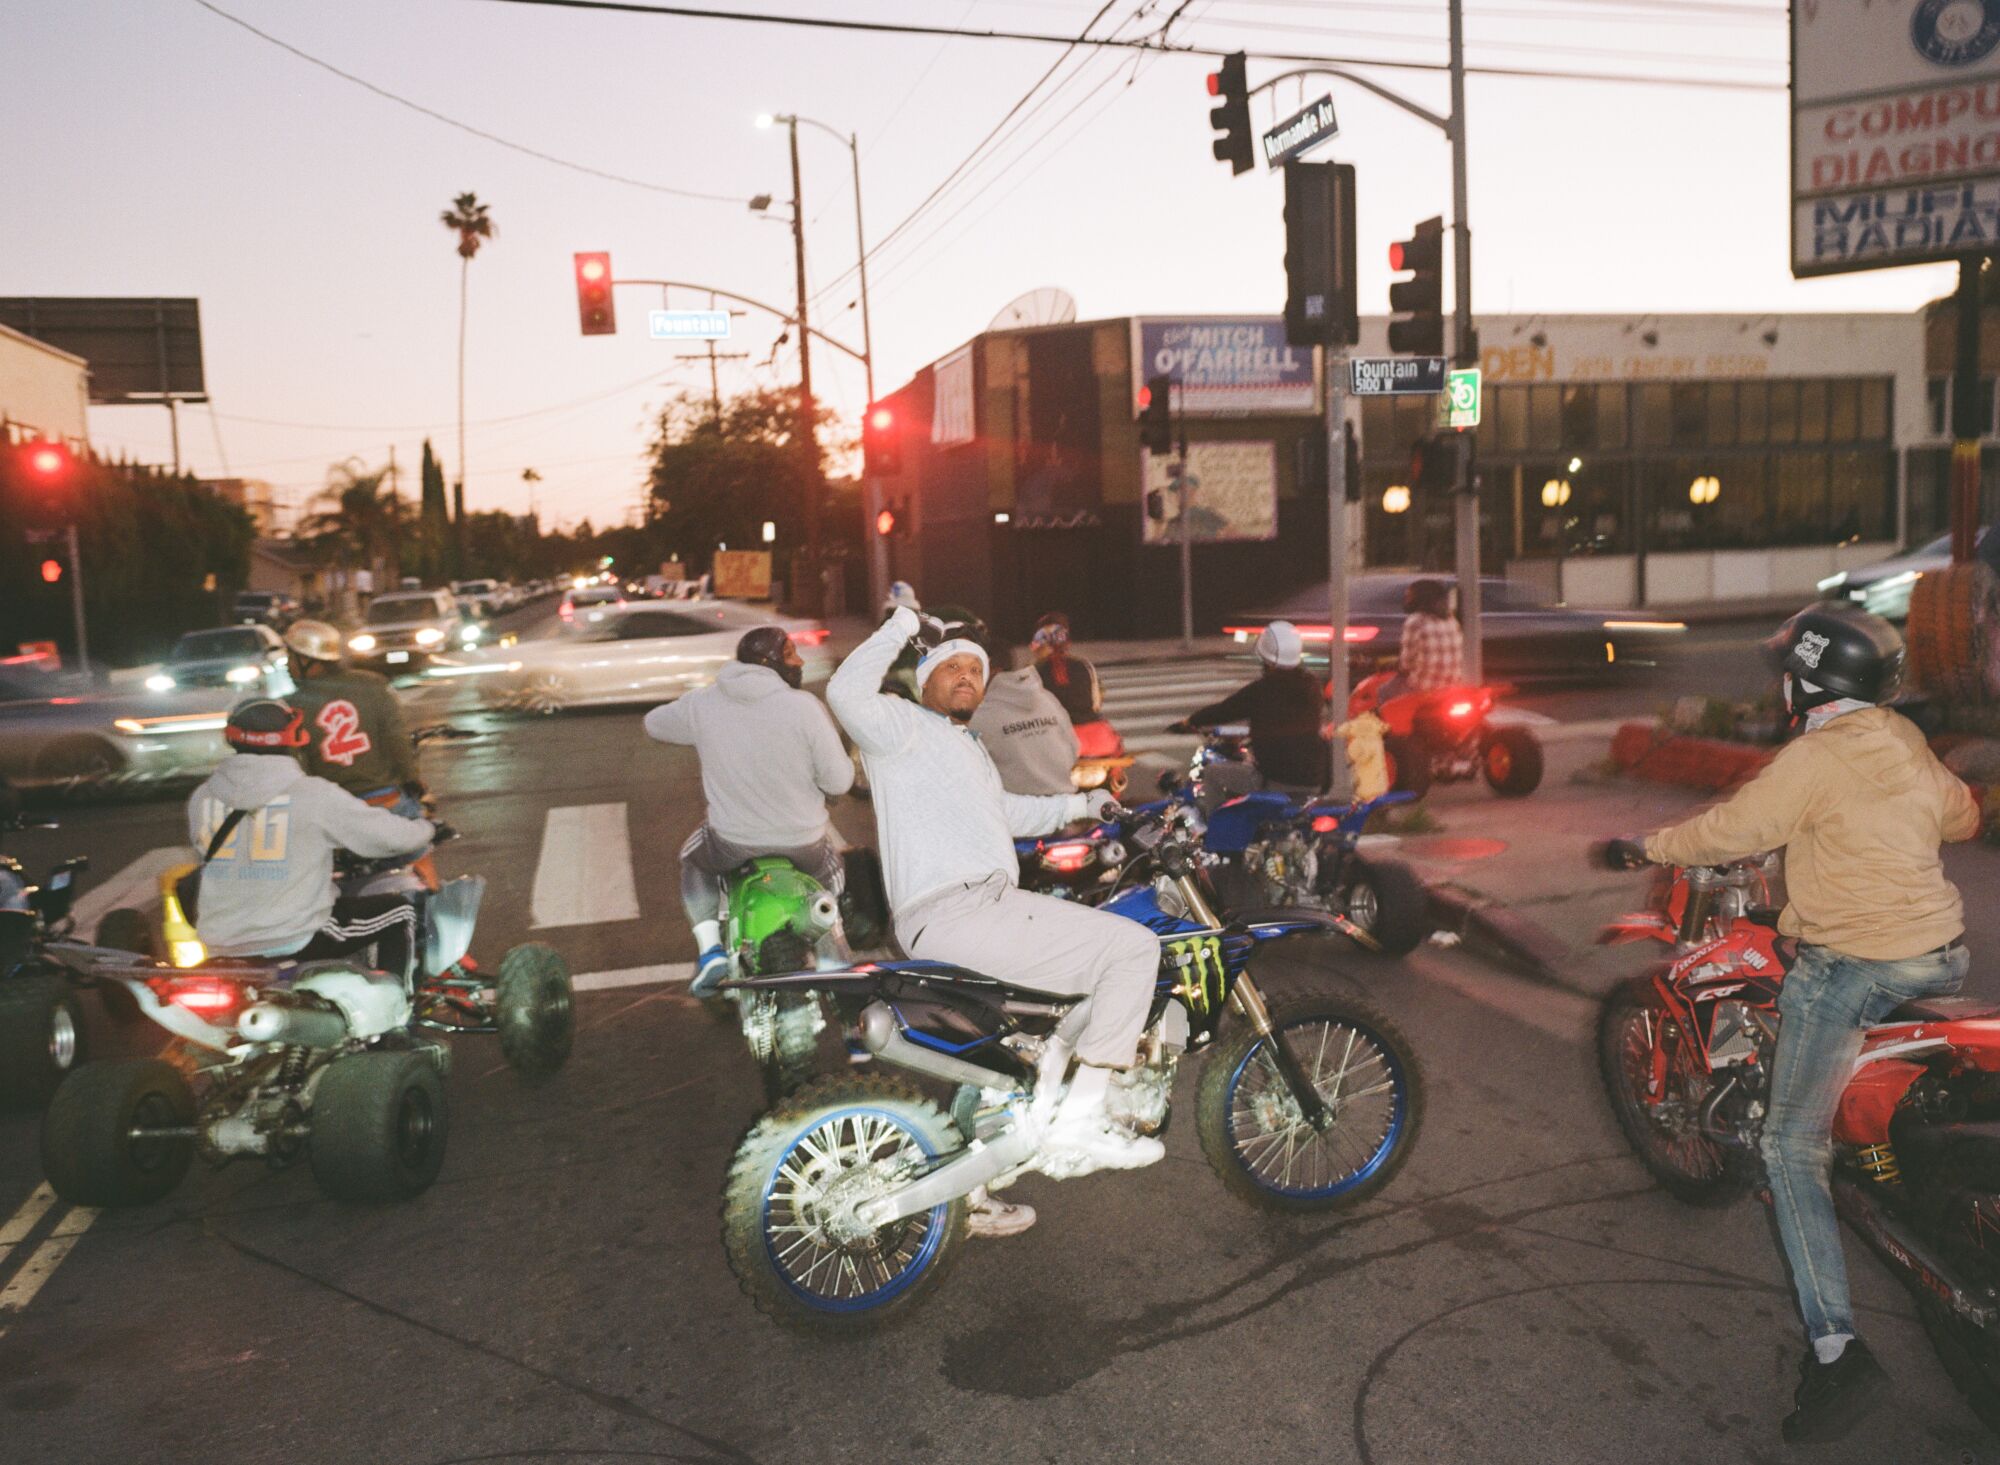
[826,608,1166,1175]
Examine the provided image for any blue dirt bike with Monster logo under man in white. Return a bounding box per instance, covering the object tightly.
[722,805,1424,1333]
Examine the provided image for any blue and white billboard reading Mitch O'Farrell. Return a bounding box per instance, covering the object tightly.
[1132,316,1320,416]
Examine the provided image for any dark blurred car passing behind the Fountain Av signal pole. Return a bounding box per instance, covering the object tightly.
[1224,574,1688,680]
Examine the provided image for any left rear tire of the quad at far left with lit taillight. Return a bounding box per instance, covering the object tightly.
[42,1059,194,1205]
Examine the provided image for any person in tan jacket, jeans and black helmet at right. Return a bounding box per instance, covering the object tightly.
[1608,602,1980,1443]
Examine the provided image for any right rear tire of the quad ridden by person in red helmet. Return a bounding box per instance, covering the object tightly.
[310,1049,450,1201]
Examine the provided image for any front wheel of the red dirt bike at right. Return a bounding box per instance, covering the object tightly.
[1598,977,1754,1205]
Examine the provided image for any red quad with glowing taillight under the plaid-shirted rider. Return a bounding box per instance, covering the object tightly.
[1348,670,1542,799]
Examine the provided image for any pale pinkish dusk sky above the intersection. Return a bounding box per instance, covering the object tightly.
[0,0,1952,524]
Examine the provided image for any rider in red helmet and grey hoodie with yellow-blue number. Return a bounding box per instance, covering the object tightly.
[188,698,438,977]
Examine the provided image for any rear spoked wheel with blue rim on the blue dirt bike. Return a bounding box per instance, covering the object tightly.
[722,1077,966,1335]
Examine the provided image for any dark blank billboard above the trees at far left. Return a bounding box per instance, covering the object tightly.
[0,296,208,406]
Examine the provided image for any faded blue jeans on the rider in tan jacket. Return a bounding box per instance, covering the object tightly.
[1764,943,1970,1341]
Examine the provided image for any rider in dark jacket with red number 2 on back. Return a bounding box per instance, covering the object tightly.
[284,620,424,819]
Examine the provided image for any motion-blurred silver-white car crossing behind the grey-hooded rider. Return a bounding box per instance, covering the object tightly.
[426,600,832,712]
